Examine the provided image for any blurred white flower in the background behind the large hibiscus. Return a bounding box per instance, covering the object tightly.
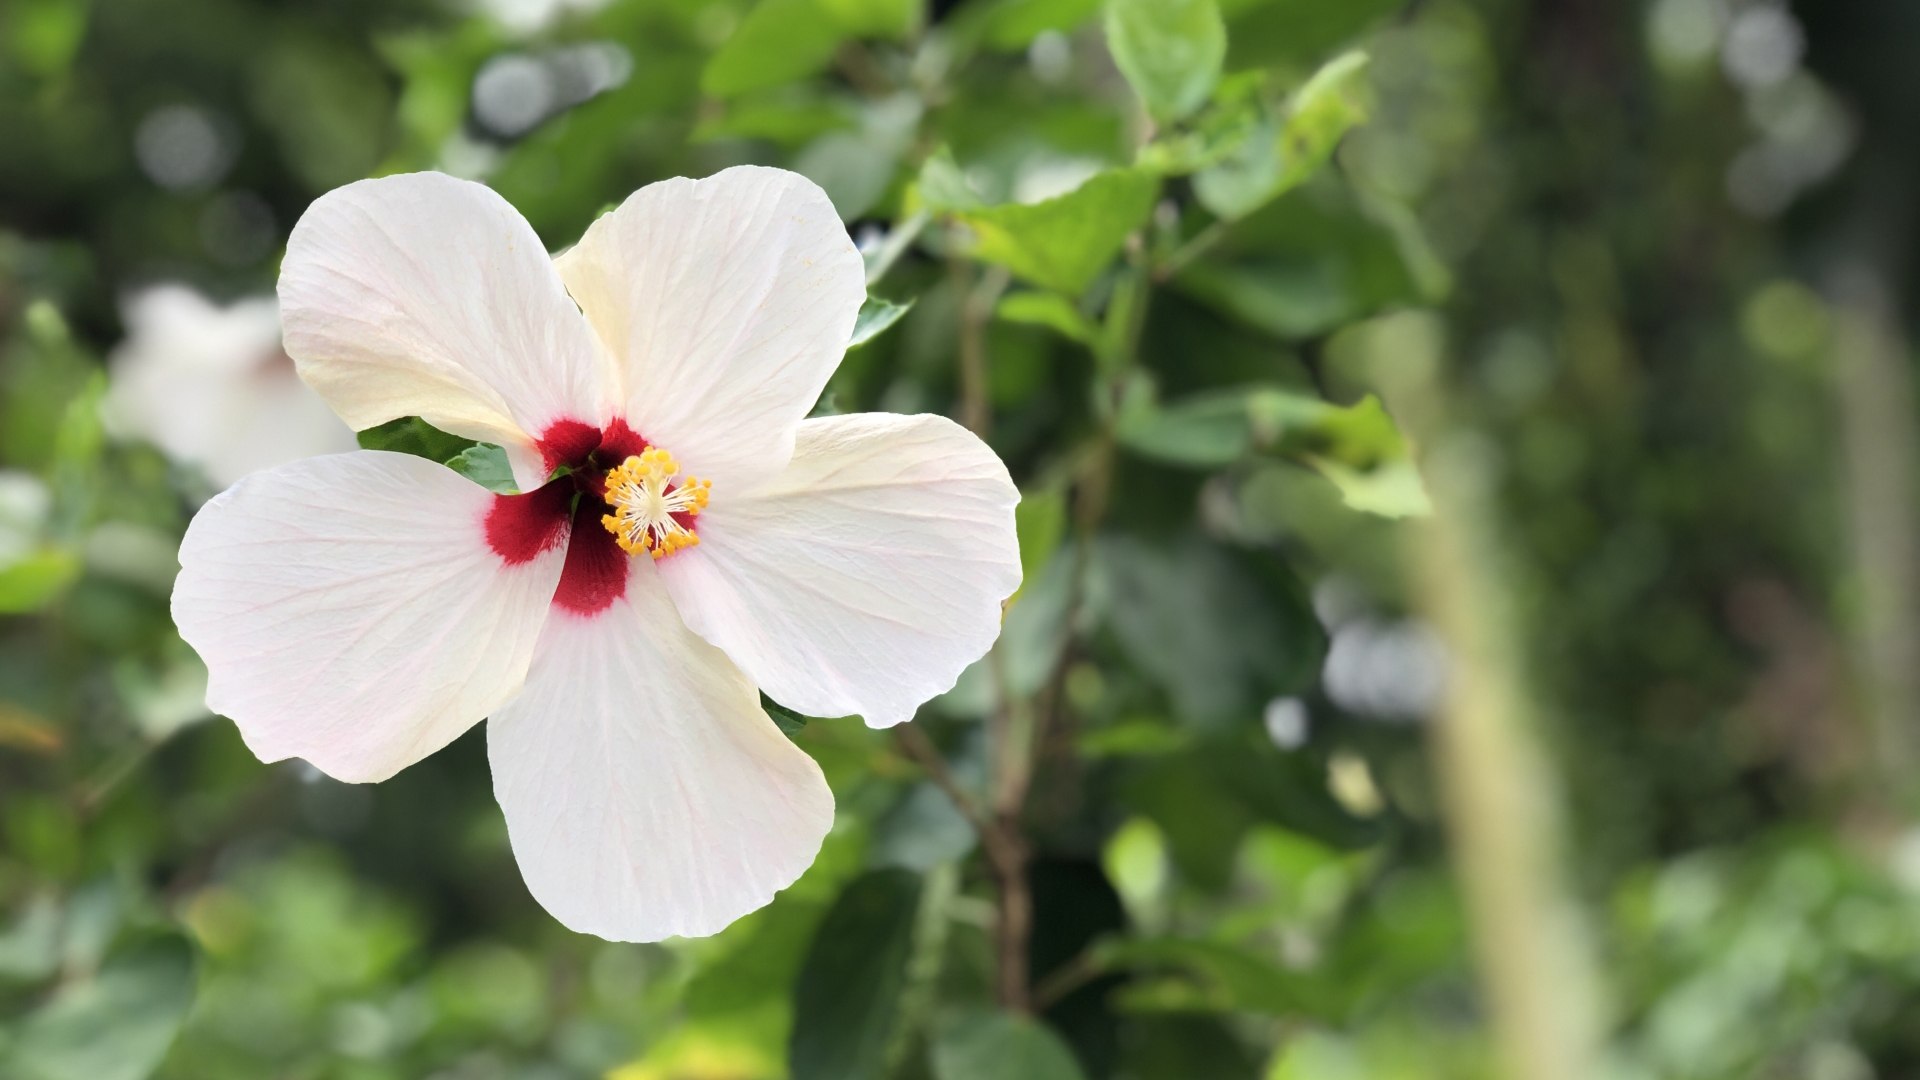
[104,284,357,486]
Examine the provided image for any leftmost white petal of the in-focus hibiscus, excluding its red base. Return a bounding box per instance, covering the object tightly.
[173,450,564,782]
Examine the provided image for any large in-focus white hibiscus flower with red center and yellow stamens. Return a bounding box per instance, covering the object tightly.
[173,167,1020,940]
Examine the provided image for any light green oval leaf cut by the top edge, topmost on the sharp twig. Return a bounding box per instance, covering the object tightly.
[1106,0,1227,123]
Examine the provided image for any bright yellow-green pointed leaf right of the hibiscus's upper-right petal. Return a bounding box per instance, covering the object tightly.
[956,169,1160,296]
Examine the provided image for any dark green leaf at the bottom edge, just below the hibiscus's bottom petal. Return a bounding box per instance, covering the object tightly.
[787,869,920,1080]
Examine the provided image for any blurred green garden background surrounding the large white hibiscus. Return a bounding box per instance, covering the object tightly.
[0,0,1920,1080]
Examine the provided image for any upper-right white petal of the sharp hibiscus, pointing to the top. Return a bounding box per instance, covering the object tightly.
[557,165,866,488]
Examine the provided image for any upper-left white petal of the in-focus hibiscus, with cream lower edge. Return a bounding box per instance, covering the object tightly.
[280,173,616,448]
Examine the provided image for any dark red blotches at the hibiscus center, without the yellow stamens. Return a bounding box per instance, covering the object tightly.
[486,419,649,615]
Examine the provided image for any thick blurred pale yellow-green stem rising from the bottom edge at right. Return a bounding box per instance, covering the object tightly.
[1369,313,1601,1080]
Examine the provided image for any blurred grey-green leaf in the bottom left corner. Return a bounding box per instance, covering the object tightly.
[4,938,194,1080]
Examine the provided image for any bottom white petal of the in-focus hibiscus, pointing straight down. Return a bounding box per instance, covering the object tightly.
[486,559,833,942]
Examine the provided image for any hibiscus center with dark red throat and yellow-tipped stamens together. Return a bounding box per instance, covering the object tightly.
[486,419,710,615]
